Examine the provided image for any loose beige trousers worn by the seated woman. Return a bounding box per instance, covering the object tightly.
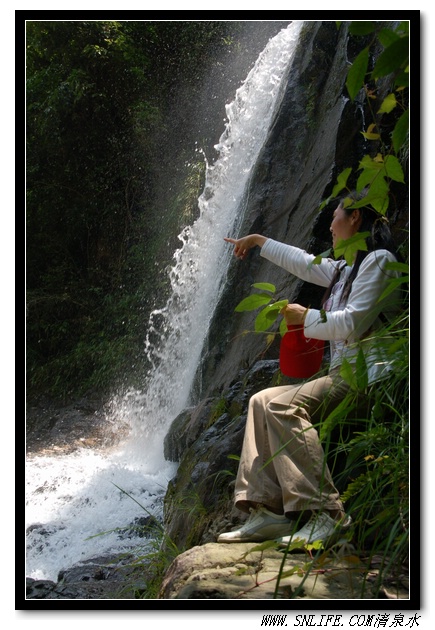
[234,370,349,514]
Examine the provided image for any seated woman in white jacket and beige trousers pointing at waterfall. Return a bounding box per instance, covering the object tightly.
[218,199,399,546]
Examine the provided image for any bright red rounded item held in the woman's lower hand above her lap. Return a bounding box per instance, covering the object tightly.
[279,325,325,378]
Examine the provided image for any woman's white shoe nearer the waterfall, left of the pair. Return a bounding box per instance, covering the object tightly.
[217,507,292,543]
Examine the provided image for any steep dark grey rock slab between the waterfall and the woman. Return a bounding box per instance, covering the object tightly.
[197,22,408,398]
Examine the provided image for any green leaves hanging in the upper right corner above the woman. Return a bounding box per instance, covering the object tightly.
[320,22,409,222]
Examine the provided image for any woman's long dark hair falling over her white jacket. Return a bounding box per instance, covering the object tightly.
[322,191,402,306]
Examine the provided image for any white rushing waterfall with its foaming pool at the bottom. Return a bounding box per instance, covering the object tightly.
[26,21,303,581]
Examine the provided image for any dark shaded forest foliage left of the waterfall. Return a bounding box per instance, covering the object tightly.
[26,20,287,396]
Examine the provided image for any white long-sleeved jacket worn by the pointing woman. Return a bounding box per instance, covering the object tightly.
[261,239,400,383]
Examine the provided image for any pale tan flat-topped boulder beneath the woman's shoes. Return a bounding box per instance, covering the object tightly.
[159,543,382,599]
